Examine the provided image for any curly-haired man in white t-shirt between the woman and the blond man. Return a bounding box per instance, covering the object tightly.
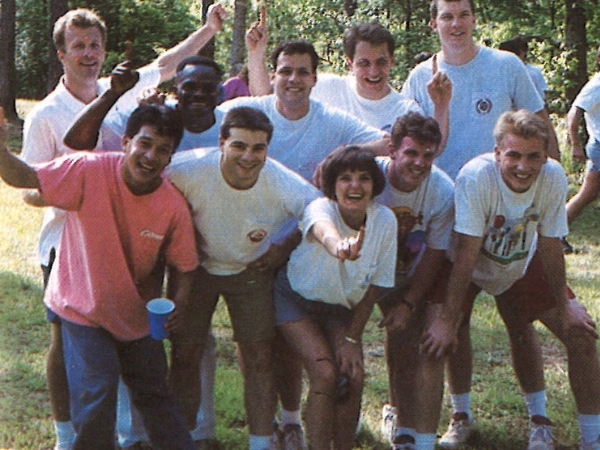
[375,112,454,450]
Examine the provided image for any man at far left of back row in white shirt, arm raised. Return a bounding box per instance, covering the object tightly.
[22,5,225,450]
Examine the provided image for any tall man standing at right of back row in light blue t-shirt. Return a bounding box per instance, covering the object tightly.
[402,0,559,448]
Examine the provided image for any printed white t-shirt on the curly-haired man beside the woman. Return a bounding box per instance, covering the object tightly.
[375,157,454,277]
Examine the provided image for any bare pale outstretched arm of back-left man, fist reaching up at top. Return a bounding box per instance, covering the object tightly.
[152,3,228,83]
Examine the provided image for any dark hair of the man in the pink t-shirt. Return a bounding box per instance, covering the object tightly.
[125,105,183,151]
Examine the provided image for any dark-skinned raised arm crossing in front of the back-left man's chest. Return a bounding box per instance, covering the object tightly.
[63,62,140,150]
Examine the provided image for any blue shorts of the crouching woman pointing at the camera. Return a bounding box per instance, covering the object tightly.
[273,266,352,326]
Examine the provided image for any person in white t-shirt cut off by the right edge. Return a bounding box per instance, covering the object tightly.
[567,47,600,253]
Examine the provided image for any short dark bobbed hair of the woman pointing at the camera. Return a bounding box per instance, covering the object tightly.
[320,145,385,200]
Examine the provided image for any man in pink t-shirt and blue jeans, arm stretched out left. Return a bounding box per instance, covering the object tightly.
[0,106,198,450]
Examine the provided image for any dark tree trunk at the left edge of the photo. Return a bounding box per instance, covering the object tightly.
[0,0,20,122]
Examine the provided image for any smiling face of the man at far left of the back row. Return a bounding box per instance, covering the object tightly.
[58,25,105,83]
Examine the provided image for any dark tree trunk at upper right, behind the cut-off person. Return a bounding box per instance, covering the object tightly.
[565,0,588,104]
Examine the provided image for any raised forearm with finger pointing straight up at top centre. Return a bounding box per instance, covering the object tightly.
[246,5,272,96]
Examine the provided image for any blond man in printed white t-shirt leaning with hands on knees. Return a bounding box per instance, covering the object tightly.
[423,110,600,449]
